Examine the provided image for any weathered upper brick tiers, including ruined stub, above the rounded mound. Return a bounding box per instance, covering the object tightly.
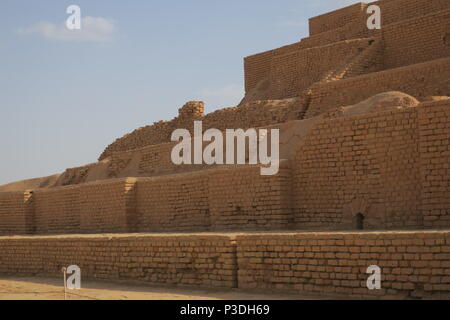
[96,0,450,164]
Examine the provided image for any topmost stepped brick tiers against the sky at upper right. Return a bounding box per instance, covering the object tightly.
[244,0,450,99]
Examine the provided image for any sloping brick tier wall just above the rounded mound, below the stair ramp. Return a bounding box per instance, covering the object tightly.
[305,58,450,118]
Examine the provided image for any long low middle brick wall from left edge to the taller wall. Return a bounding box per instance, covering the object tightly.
[0,165,291,234]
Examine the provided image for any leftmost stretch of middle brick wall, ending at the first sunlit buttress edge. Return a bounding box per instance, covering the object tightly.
[16,178,138,234]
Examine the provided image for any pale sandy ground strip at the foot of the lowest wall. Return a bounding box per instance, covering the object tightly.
[0,277,338,300]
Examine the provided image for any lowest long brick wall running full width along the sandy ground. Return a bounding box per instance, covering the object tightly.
[0,230,450,298]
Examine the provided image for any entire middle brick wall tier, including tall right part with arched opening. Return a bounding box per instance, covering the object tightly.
[1,99,450,234]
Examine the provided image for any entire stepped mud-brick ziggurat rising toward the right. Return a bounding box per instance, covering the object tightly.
[0,0,450,298]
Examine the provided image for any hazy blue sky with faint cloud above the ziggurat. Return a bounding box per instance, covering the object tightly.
[0,0,356,184]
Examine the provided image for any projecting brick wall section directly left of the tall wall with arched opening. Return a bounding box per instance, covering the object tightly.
[208,165,292,231]
